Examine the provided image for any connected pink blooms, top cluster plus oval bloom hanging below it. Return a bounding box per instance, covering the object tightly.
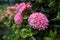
[13,3,31,24]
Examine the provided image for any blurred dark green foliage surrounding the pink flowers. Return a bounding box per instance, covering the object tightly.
[0,0,60,40]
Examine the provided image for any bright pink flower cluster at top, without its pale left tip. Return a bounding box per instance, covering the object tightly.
[16,3,31,13]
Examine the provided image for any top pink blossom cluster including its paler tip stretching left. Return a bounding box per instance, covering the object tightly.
[9,2,31,13]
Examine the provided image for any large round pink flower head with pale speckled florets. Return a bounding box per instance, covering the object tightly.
[28,12,49,30]
